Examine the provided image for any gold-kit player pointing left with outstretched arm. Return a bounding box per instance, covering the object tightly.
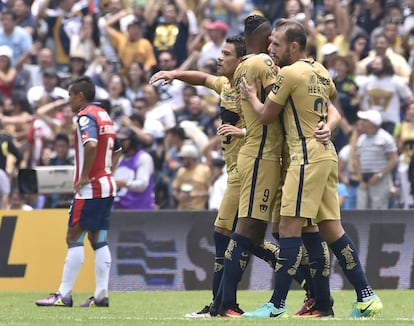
[150,36,284,317]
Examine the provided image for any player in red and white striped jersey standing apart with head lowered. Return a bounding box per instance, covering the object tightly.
[36,76,121,307]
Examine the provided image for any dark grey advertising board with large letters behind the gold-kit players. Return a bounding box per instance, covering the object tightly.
[108,210,414,291]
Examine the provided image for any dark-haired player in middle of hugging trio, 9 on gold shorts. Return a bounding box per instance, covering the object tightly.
[209,15,284,317]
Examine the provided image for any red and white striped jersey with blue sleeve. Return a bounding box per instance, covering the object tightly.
[74,103,120,199]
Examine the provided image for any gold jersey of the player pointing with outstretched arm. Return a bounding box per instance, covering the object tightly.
[212,77,244,178]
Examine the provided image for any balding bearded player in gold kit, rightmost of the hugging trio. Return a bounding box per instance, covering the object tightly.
[241,19,383,318]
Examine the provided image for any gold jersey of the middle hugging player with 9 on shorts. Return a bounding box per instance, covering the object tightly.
[234,53,284,161]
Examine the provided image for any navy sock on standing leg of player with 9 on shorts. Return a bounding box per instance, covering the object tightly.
[220,233,253,310]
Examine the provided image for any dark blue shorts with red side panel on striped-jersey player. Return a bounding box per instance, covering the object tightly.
[69,197,114,231]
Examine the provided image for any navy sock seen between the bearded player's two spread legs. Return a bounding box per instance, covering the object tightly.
[302,232,331,310]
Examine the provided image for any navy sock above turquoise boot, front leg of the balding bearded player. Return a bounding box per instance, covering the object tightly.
[270,237,302,308]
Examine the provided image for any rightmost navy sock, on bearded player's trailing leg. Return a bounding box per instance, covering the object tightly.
[329,233,374,301]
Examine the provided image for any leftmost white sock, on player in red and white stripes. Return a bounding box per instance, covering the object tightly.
[59,246,85,297]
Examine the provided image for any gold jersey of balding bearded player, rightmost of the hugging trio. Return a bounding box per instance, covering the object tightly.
[269,59,337,165]
